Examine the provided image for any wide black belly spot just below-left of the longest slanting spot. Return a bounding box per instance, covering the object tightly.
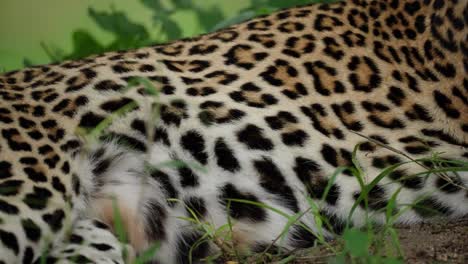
[219,183,267,222]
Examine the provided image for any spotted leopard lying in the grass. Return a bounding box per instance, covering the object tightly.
[0,0,468,264]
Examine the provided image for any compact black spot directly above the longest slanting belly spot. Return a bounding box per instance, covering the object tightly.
[237,124,274,151]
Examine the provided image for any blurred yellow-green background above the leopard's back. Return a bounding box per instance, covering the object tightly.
[0,0,333,72]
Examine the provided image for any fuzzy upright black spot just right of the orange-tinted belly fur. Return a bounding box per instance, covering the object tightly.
[144,200,167,242]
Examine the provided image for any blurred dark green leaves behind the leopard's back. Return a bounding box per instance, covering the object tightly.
[38,0,336,66]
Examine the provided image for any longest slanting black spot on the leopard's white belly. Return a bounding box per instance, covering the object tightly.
[253,158,299,212]
